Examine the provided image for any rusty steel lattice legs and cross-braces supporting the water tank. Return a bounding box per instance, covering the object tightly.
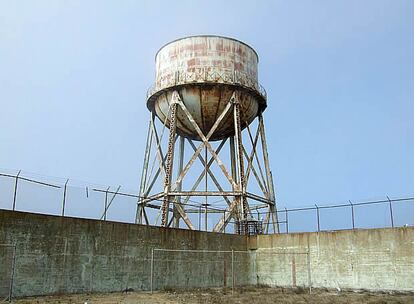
[136,89,279,232]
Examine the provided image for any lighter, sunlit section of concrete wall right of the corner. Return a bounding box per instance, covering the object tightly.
[256,227,414,291]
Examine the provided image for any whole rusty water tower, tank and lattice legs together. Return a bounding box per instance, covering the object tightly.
[136,35,278,234]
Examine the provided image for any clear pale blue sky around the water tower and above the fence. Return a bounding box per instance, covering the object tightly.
[0,0,414,226]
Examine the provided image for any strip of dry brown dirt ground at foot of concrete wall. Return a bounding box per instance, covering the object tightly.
[12,287,414,304]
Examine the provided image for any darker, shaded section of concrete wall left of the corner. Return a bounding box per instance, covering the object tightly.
[0,210,250,297]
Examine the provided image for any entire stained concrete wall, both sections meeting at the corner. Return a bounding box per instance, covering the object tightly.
[0,210,414,297]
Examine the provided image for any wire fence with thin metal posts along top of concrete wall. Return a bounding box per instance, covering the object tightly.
[0,171,414,233]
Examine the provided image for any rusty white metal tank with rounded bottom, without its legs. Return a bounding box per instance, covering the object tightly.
[147,35,266,141]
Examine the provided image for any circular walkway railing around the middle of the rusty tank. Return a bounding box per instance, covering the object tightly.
[147,67,267,100]
